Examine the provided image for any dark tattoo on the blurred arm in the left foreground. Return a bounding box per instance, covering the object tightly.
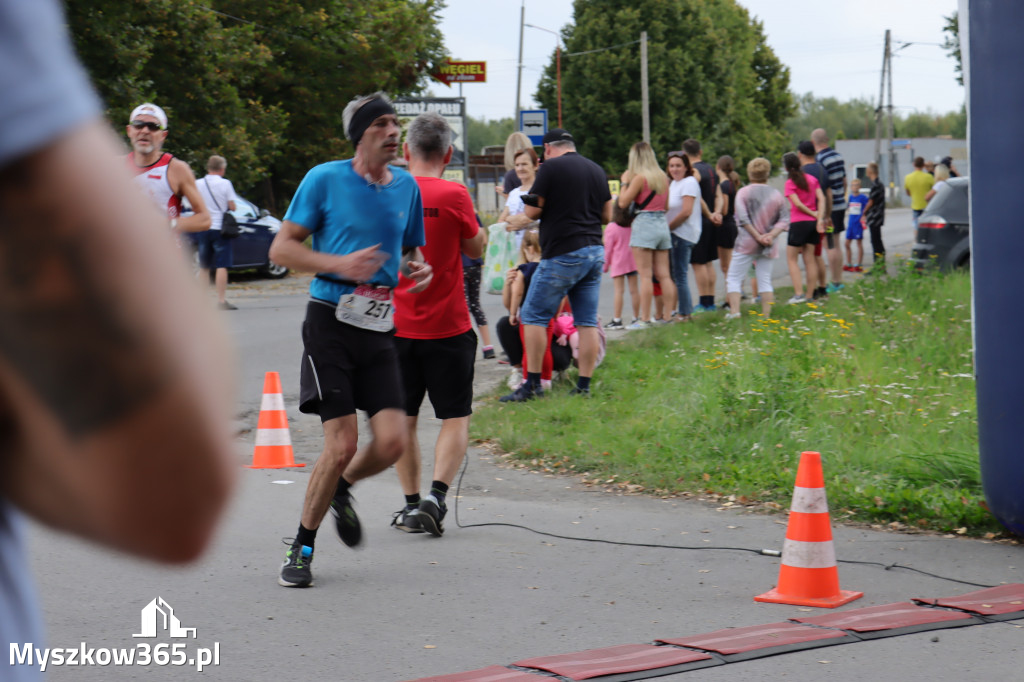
[0,162,169,436]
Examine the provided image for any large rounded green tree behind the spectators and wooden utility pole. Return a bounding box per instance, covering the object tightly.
[537,0,793,173]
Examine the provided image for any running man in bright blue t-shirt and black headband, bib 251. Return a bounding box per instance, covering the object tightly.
[270,92,432,587]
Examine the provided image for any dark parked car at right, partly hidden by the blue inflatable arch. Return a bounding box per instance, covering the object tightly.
[913,177,971,269]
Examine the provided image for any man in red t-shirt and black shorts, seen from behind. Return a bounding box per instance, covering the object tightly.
[391,112,485,537]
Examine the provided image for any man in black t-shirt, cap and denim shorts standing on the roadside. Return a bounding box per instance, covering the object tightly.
[502,128,611,402]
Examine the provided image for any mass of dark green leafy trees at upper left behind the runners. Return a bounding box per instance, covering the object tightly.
[68,0,444,208]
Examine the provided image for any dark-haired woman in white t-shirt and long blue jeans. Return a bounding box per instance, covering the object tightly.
[665,152,700,322]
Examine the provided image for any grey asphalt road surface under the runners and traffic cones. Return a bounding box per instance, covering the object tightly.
[25,206,1024,682]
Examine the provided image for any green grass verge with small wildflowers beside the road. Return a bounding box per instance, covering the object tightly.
[472,268,1001,535]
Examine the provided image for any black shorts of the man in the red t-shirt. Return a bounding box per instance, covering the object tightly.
[394,330,476,419]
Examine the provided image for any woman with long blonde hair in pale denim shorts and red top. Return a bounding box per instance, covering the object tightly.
[618,142,676,329]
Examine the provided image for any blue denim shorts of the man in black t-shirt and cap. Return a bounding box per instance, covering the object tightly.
[520,246,604,327]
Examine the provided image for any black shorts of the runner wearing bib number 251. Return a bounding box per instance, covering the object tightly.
[299,301,406,422]
